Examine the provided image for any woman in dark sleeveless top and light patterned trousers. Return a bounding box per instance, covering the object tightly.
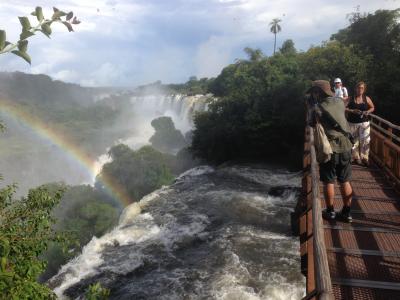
[346,81,375,166]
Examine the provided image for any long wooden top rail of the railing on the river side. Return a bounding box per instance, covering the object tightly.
[308,126,333,300]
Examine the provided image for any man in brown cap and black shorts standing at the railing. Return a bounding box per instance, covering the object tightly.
[307,80,353,222]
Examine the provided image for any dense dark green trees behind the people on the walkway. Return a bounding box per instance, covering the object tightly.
[191,10,400,167]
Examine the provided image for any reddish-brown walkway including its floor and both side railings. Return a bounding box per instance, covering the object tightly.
[295,116,400,300]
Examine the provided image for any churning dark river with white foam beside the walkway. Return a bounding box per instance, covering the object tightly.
[51,166,304,299]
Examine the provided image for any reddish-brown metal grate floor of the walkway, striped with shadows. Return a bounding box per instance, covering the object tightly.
[320,166,400,300]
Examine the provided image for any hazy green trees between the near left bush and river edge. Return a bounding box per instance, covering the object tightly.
[41,183,121,281]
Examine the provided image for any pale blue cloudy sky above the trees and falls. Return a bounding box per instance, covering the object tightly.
[0,0,400,87]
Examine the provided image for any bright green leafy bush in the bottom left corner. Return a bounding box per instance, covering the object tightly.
[0,186,64,299]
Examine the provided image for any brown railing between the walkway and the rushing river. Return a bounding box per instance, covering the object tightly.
[300,126,333,300]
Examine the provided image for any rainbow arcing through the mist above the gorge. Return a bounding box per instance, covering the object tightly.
[0,98,134,206]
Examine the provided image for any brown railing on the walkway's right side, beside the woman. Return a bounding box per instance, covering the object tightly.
[370,114,400,191]
